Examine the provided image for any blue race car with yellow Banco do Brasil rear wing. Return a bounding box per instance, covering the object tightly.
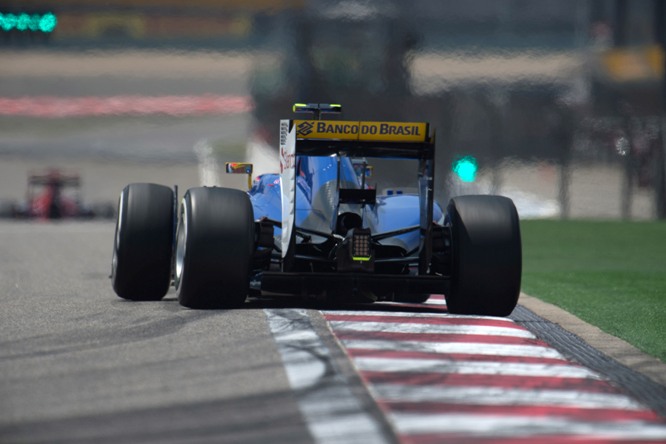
[111,104,522,316]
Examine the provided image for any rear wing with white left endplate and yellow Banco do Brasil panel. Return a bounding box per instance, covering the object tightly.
[279,118,435,273]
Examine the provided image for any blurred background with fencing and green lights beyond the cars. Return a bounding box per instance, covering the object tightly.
[0,0,666,219]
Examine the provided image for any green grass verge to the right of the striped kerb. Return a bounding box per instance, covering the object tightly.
[521,220,666,362]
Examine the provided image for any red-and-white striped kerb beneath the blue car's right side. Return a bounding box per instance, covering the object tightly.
[324,296,666,443]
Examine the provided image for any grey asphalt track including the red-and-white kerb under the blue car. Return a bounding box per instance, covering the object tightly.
[0,222,666,443]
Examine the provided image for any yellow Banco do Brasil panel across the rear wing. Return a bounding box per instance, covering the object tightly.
[293,120,429,142]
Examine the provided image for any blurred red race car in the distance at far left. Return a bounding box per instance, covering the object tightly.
[0,168,115,220]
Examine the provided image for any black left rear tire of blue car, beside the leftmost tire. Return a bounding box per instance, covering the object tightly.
[175,187,254,309]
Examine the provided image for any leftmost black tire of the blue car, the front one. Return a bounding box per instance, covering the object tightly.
[111,183,175,301]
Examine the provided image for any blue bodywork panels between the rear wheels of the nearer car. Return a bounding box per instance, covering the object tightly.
[249,156,443,252]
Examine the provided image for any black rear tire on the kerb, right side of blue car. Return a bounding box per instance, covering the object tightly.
[445,195,522,316]
